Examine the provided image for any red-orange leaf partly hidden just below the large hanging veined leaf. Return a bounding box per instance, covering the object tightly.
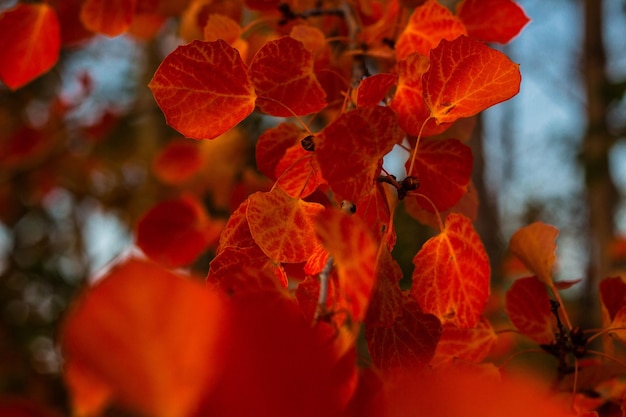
[430,318,498,367]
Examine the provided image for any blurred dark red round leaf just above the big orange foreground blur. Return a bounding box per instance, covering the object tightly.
[137,196,223,267]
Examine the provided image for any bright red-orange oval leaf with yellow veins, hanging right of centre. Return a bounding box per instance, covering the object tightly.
[411,213,490,328]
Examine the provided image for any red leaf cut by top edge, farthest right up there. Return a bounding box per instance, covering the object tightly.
[456,0,530,43]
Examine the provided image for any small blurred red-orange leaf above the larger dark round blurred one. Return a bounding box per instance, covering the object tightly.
[152,140,203,185]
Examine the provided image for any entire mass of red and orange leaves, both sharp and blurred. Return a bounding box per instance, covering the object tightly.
[8,0,624,417]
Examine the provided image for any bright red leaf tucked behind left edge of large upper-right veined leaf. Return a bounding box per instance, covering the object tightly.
[391,53,450,137]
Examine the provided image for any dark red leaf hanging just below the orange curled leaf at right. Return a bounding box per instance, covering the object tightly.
[505,277,556,344]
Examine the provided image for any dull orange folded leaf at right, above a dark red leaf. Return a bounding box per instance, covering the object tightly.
[509,222,559,285]
